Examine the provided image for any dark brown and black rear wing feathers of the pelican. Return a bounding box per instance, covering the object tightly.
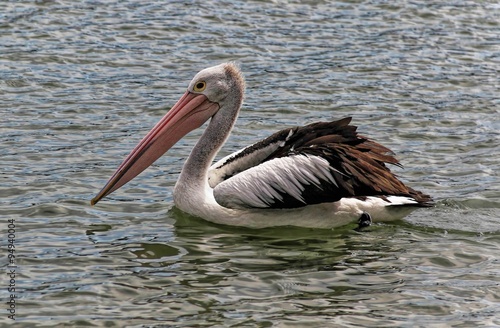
[266,117,432,206]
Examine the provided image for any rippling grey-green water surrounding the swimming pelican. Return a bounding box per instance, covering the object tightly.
[0,0,500,327]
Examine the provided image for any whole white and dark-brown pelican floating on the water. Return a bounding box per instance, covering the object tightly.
[91,63,432,228]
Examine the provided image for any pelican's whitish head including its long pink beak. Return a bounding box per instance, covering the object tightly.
[91,63,244,205]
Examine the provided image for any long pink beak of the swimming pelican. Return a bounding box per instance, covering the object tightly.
[90,91,219,205]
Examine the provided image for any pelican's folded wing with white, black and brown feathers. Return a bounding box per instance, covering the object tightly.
[211,118,427,208]
